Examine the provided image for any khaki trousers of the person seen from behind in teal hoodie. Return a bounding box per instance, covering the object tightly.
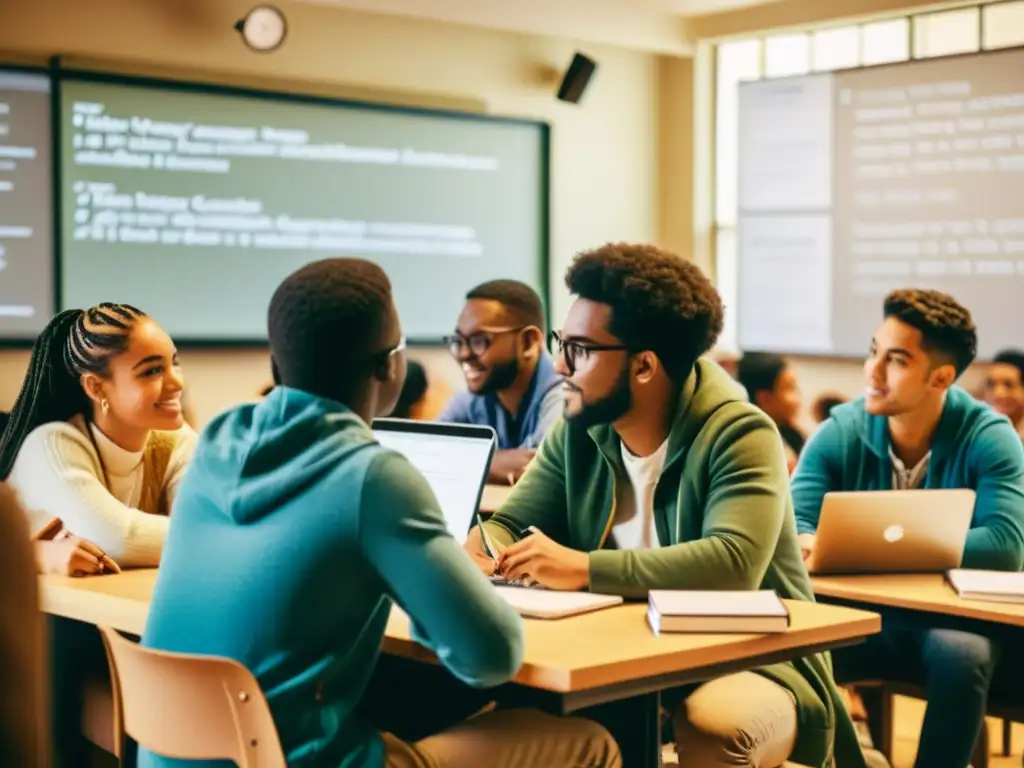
[384,710,623,768]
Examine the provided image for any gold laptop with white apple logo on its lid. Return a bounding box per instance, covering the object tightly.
[814,488,975,573]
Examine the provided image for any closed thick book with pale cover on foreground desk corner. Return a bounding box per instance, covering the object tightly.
[647,590,790,635]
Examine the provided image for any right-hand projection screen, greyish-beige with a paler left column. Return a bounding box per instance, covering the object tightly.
[739,46,1024,356]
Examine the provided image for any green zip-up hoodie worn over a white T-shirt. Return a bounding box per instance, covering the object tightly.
[484,359,864,768]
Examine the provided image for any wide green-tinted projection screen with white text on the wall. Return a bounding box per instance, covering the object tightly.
[62,81,542,340]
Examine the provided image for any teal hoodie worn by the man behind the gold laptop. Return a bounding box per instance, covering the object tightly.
[793,387,1024,570]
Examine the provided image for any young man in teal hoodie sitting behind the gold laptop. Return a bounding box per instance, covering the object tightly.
[793,290,1024,768]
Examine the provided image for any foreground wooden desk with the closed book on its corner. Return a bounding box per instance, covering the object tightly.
[40,569,882,768]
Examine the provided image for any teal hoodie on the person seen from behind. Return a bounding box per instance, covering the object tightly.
[139,387,523,768]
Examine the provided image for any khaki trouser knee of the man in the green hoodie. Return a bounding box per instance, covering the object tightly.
[673,672,797,768]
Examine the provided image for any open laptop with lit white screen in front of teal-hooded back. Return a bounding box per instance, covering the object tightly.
[373,419,496,544]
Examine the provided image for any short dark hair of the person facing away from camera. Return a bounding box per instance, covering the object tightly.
[267,259,394,402]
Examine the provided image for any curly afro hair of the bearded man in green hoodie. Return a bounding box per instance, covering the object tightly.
[565,243,725,382]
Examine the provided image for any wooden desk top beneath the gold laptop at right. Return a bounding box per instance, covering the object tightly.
[812,573,1024,627]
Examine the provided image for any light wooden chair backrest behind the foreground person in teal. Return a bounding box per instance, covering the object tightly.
[99,627,287,768]
